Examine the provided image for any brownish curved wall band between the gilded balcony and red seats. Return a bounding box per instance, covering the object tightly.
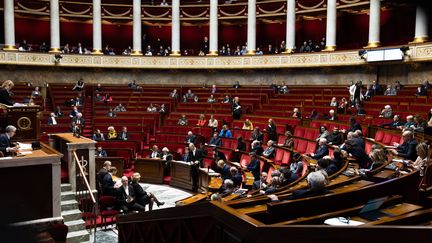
[0,63,432,85]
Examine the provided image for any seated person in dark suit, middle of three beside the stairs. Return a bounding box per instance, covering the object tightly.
[116,176,145,213]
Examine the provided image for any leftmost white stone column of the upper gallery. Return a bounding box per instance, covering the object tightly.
[3,0,16,51]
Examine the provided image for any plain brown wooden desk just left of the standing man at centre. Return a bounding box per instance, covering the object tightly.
[135,158,165,184]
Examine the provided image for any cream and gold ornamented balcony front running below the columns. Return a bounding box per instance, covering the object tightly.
[0,43,432,69]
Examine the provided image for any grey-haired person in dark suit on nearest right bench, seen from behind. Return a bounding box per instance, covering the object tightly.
[289,171,330,199]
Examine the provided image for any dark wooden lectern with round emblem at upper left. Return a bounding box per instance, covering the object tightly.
[0,104,41,141]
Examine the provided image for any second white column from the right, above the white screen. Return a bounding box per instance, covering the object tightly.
[367,0,381,48]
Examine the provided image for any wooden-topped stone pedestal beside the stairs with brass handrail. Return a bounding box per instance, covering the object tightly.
[48,133,96,192]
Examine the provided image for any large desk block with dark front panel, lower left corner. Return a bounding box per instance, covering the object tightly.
[0,143,62,224]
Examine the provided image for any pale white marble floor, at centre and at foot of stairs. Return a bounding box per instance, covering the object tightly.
[91,183,192,243]
